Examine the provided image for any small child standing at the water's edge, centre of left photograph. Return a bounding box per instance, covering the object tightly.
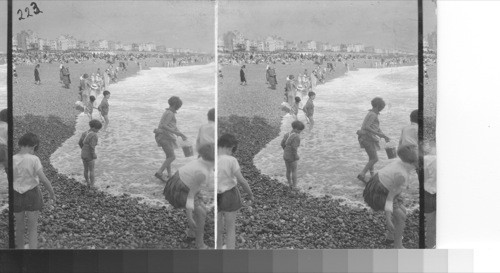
[78,119,102,187]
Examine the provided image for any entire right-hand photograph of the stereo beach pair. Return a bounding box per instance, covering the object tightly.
[216,1,422,249]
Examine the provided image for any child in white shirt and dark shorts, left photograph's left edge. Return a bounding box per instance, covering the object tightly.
[12,133,56,249]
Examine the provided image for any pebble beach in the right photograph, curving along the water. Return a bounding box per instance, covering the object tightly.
[218,60,419,249]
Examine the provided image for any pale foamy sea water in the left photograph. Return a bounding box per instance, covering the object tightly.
[50,64,215,206]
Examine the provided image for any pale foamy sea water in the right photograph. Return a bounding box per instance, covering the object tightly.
[254,66,418,208]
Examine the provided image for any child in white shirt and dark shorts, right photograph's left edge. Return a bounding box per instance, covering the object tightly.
[217,134,253,249]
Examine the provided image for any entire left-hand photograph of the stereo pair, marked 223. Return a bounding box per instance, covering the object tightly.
[12,1,216,249]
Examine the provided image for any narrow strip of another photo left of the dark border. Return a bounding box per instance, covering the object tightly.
[0,1,9,249]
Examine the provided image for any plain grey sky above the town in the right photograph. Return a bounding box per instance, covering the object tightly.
[218,0,435,53]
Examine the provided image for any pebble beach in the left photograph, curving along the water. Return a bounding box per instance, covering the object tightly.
[6,60,214,249]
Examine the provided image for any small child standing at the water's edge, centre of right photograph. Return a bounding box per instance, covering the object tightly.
[281,120,305,189]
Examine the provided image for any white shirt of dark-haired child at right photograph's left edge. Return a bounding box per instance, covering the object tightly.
[217,155,240,193]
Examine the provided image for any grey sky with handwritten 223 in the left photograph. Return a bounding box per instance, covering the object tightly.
[7,0,215,52]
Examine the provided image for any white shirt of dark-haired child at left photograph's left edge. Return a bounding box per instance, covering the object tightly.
[12,154,42,194]
